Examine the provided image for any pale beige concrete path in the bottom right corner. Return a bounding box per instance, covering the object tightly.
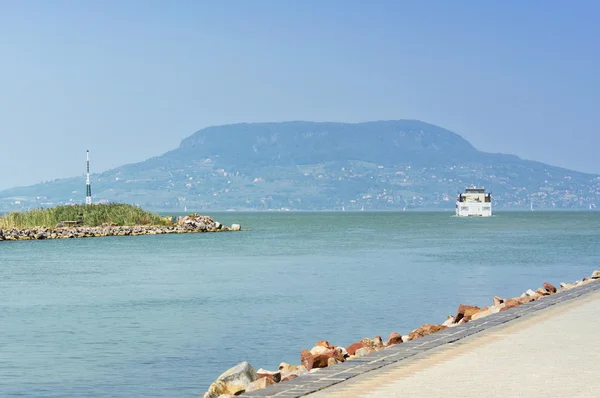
[308,291,600,398]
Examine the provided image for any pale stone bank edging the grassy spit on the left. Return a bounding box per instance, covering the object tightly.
[0,214,241,241]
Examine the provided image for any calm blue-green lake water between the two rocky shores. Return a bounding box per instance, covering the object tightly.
[0,212,600,397]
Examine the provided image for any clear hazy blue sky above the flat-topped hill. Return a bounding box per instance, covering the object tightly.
[0,0,600,188]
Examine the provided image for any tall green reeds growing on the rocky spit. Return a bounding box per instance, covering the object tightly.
[0,203,171,229]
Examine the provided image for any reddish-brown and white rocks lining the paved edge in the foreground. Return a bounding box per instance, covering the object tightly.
[202,270,600,398]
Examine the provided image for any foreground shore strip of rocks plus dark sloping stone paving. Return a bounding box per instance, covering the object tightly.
[201,270,600,398]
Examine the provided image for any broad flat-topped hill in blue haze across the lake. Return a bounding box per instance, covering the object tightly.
[0,120,600,211]
